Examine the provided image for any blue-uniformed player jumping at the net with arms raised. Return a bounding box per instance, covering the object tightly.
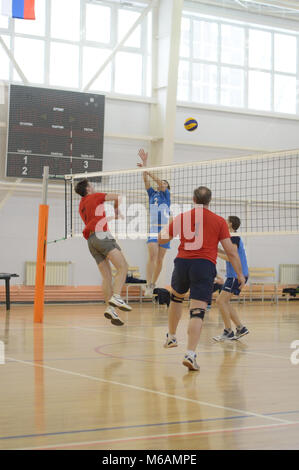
[138,149,170,296]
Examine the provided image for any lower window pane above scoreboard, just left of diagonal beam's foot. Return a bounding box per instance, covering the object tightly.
[50,42,79,88]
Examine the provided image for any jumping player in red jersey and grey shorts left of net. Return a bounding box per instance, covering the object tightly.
[75,179,132,325]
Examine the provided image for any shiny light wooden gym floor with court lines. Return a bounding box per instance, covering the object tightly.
[0,302,299,450]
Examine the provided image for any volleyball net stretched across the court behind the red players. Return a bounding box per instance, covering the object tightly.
[65,150,299,240]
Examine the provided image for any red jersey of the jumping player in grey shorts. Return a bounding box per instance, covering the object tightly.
[79,193,109,240]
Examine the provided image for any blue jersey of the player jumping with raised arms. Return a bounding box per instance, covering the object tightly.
[147,187,170,226]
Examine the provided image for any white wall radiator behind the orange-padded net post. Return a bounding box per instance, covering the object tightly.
[25,261,72,286]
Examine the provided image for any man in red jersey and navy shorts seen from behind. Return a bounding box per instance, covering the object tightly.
[159,186,245,370]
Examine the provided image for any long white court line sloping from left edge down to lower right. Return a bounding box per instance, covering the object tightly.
[7,357,294,424]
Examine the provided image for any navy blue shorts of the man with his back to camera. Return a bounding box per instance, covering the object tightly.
[171,258,217,302]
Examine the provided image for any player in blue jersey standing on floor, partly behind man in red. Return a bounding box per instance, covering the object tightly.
[213,215,249,341]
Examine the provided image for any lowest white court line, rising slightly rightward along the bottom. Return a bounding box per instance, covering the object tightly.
[15,422,299,450]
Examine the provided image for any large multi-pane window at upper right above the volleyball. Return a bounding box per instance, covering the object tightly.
[178,11,299,114]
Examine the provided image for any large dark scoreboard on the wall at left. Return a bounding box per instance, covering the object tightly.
[6,85,105,178]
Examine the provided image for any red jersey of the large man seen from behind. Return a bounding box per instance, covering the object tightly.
[169,207,230,264]
